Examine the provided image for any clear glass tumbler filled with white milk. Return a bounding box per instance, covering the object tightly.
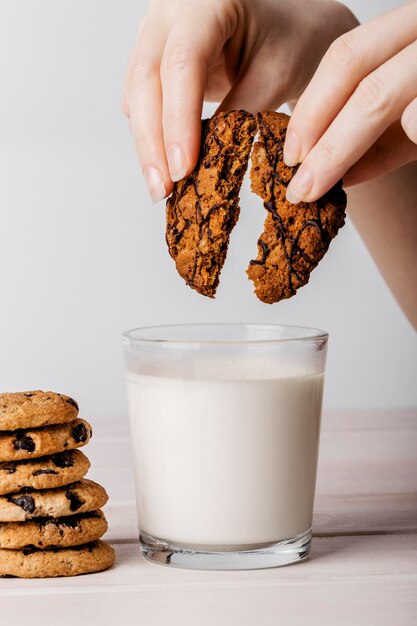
[123,324,328,569]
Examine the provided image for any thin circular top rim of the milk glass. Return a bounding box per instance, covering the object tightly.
[122,322,329,346]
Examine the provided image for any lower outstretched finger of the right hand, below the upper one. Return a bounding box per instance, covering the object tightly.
[287,41,417,203]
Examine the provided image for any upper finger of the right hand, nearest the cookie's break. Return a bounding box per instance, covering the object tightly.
[284,5,417,165]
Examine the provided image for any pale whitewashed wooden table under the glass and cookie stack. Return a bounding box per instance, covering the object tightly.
[0,410,417,626]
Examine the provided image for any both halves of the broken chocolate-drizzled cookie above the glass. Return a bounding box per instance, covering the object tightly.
[166,111,346,304]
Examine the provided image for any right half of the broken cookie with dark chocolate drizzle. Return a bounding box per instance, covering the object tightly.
[247,111,346,304]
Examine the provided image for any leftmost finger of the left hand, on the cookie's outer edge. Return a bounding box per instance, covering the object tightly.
[123,19,172,203]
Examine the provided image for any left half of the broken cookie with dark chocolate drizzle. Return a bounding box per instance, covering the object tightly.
[166,111,256,298]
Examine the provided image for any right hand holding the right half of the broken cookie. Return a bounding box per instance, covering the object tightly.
[284,1,417,204]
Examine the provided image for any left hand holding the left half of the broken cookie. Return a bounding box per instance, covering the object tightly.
[122,0,358,202]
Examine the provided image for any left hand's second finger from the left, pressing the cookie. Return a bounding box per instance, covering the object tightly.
[161,9,233,181]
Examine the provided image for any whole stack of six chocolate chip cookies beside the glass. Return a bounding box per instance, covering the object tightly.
[0,391,114,578]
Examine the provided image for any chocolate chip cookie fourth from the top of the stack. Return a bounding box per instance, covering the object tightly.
[0,478,108,522]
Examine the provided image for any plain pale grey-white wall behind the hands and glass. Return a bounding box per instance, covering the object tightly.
[0,0,417,416]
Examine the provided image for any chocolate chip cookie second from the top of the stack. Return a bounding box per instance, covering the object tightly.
[0,419,92,462]
